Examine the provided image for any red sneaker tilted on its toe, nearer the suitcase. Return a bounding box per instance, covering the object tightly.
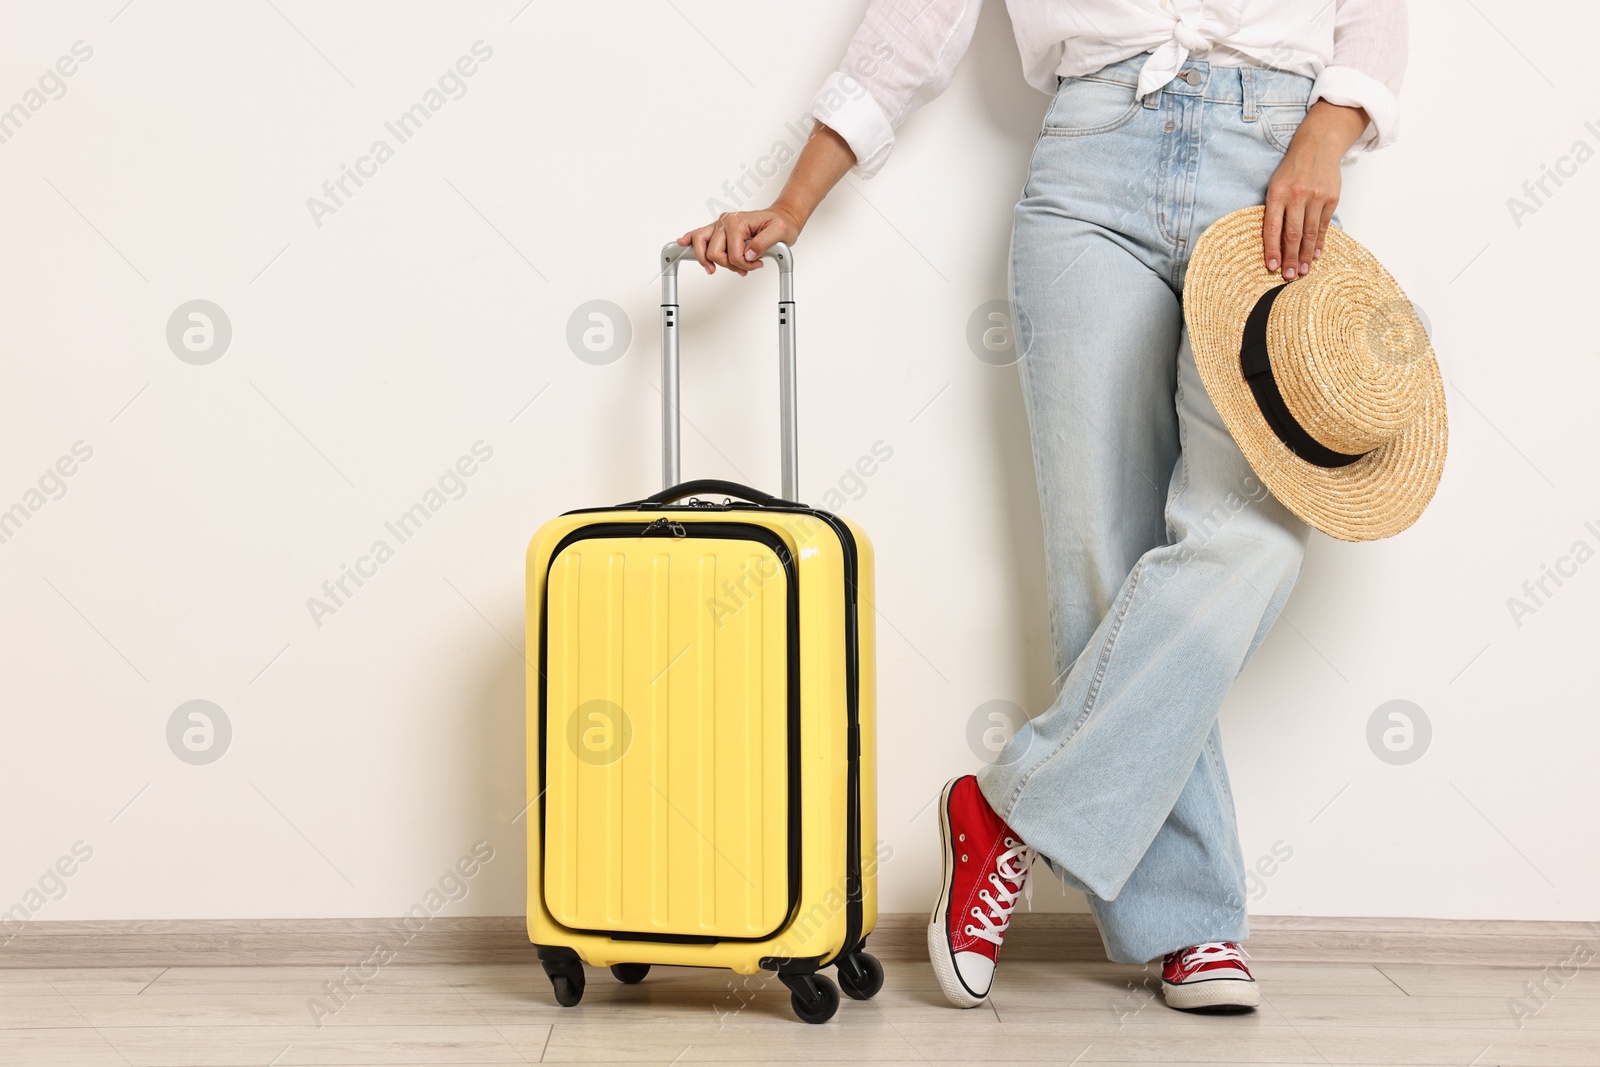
[928,774,1034,1008]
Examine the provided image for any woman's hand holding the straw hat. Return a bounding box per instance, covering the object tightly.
[1261,101,1366,282]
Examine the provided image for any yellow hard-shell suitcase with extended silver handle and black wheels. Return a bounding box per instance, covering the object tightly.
[528,245,883,1022]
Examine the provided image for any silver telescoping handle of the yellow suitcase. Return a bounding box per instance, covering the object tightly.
[661,242,800,501]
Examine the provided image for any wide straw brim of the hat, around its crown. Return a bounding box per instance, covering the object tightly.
[1184,206,1448,541]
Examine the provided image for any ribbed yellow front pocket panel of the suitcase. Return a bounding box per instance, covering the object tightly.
[541,523,798,941]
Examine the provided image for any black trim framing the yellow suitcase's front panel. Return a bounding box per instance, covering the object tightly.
[539,521,806,944]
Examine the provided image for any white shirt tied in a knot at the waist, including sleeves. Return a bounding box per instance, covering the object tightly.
[811,0,1406,178]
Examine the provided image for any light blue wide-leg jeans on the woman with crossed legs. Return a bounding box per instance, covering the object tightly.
[978,56,1310,963]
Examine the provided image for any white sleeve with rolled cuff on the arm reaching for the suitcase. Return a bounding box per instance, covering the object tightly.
[811,0,982,178]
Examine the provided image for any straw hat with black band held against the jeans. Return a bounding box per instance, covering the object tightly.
[1184,206,1446,541]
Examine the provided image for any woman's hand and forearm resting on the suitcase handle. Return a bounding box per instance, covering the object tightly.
[678,123,856,278]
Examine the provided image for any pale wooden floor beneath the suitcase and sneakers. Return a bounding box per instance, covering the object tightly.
[0,960,1600,1067]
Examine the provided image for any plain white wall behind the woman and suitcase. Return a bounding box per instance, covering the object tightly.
[0,0,1600,920]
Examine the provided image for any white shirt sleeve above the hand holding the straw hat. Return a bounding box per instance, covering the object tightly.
[1310,0,1408,158]
